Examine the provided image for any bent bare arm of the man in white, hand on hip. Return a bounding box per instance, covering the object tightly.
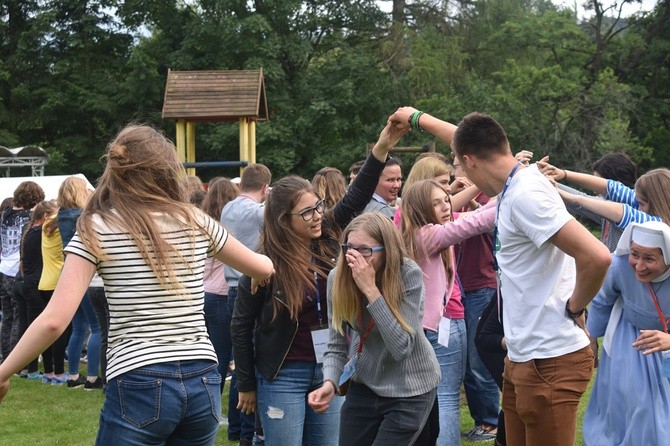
[549,219,612,313]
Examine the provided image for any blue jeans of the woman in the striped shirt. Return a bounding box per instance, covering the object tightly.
[96,360,221,446]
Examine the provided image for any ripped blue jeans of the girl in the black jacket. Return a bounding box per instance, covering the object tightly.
[256,362,344,446]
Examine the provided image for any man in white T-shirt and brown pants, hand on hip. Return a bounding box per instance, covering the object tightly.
[452,113,611,446]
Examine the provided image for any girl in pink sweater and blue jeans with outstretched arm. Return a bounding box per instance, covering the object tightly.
[401,180,496,445]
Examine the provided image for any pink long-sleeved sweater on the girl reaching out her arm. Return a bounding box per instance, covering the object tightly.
[416,205,496,331]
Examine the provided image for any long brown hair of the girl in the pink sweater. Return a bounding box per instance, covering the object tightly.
[400,180,454,288]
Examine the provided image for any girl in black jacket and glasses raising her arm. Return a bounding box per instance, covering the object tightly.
[231,119,408,446]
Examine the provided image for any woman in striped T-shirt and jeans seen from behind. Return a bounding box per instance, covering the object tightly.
[0,125,273,445]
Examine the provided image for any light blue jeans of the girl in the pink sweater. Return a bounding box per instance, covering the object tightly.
[426,319,468,446]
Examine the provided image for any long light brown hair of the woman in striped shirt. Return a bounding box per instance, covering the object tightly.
[77,125,204,289]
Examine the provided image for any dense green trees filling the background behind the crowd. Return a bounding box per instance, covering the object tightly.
[0,0,670,179]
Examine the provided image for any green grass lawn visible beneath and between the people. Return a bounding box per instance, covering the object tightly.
[0,377,593,446]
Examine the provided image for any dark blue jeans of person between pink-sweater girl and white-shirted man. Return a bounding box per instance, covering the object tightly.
[463,288,500,426]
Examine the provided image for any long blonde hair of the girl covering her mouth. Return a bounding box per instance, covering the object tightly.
[332,213,412,334]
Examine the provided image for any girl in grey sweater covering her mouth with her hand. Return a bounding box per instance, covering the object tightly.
[309,213,440,446]
